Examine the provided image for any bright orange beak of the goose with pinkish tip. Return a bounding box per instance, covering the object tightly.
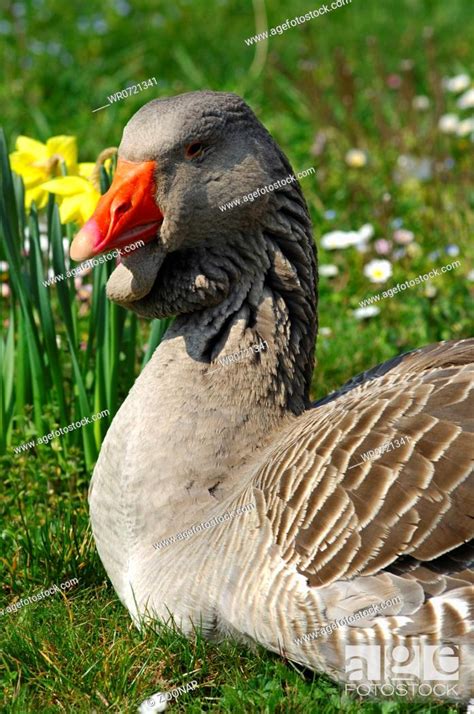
[69,159,163,261]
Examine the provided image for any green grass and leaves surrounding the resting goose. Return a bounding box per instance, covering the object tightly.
[0,0,474,714]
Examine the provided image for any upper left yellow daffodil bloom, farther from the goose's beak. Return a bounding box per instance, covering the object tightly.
[10,136,78,208]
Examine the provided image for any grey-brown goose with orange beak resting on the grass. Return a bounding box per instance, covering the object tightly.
[70,91,474,699]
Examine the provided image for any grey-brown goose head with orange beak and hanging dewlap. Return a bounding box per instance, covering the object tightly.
[70,91,312,317]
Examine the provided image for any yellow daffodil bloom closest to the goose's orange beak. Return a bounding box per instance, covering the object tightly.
[42,174,100,225]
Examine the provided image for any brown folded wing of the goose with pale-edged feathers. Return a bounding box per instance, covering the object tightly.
[252,340,474,590]
